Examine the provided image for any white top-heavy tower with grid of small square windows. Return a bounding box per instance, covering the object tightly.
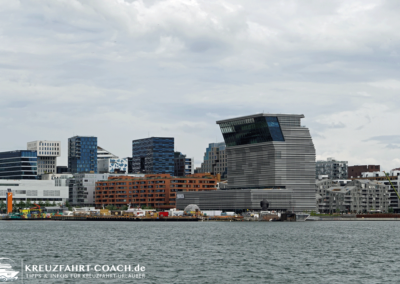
[27,140,61,175]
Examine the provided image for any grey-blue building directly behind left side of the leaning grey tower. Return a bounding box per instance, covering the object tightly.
[198,142,228,179]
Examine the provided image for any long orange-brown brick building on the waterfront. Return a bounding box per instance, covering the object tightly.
[95,173,218,209]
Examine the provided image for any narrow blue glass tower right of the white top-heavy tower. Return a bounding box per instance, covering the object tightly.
[68,136,97,173]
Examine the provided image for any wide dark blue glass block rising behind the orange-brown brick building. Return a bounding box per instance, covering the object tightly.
[132,137,174,175]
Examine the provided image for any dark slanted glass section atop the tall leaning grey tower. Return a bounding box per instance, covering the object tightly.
[220,116,285,147]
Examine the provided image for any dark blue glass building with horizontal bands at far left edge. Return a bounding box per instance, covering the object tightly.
[0,150,38,179]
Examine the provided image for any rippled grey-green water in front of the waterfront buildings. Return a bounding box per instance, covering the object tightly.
[0,221,400,284]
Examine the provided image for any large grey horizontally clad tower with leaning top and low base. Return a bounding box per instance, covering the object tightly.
[177,113,315,212]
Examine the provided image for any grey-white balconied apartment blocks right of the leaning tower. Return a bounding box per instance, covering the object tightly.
[317,180,390,213]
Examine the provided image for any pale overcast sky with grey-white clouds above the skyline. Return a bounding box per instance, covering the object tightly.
[0,0,400,170]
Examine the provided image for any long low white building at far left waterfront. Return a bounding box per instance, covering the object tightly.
[0,180,68,204]
